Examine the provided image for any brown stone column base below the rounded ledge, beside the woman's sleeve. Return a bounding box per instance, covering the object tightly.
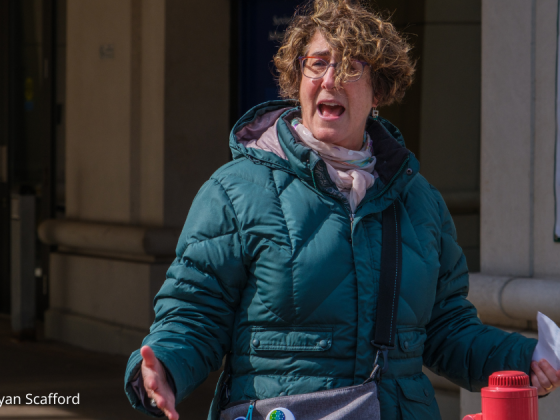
[45,253,168,355]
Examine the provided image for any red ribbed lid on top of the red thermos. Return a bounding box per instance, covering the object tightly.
[481,370,537,398]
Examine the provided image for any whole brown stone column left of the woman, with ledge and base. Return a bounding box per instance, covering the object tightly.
[40,0,230,354]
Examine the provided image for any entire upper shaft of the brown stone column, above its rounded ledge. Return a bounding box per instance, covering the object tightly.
[66,0,229,226]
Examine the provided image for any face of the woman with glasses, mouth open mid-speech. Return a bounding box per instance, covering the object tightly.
[299,31,376,150]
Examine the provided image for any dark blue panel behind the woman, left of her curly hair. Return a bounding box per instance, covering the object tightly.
[238,0,305,116]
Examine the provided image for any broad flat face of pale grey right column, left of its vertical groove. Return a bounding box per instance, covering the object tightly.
[481,0,536,276]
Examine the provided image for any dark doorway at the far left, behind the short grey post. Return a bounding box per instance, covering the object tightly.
[0,0,65,318]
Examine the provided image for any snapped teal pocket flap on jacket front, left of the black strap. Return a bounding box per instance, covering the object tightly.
[251,327,332,353]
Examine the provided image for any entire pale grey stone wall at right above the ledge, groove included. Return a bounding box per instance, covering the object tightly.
[481,0,560,277]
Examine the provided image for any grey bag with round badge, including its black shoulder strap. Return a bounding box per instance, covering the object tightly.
[215,201,402,420]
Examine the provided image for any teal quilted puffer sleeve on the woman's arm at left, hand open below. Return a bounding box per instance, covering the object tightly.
[125,179,247,414]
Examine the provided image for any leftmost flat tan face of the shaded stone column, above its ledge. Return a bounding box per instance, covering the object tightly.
[66,0,132,223]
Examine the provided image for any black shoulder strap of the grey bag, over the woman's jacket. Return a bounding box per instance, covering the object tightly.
[371,201,402,373]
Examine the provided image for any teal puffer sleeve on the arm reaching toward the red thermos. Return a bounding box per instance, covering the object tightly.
[423,187,537,391]
